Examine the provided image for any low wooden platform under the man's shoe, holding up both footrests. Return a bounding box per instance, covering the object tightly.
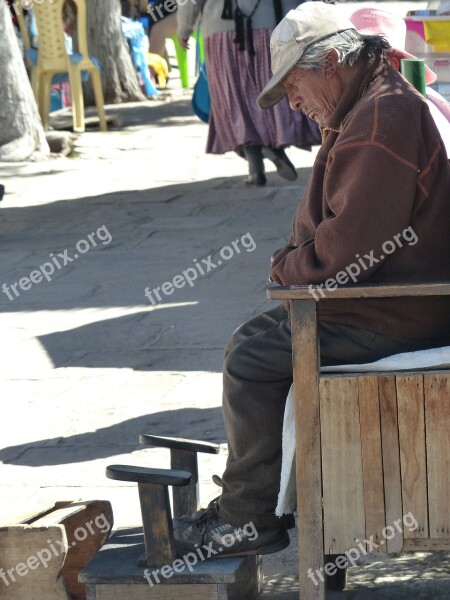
[80,528,262,600]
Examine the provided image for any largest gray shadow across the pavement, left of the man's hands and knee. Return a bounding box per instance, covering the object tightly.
[0,169,309,372]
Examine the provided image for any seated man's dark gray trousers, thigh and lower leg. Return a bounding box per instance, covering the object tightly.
[219,305,436,529]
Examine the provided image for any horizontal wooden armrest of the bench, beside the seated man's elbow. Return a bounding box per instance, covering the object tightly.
[267,281,450,301]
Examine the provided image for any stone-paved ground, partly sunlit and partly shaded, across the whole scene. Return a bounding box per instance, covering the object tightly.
[0,3,450,600]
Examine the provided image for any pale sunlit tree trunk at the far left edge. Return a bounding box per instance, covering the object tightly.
[0,0,50,162]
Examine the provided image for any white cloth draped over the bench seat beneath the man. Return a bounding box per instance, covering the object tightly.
[275,346,450,517]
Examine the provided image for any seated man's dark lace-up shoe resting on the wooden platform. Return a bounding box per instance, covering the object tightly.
[173,498,290,559]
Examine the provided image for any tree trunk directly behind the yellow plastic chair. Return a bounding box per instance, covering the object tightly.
[85,0,145,104]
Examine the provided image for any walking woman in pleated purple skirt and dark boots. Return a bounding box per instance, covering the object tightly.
[177,0,321,186]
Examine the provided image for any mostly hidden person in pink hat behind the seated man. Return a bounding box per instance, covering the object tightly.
[350,8,450,159]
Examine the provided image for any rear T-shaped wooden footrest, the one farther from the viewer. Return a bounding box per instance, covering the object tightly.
[139,433,220,517]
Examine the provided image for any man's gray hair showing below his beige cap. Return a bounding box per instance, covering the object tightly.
[295,29,390,70]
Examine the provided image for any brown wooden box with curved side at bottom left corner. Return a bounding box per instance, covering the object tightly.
[0,500,113,600]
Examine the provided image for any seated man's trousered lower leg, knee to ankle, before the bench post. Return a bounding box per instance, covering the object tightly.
[219,306,292,528]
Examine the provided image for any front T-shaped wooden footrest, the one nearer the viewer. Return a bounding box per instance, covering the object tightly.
[106,465,191,567]
